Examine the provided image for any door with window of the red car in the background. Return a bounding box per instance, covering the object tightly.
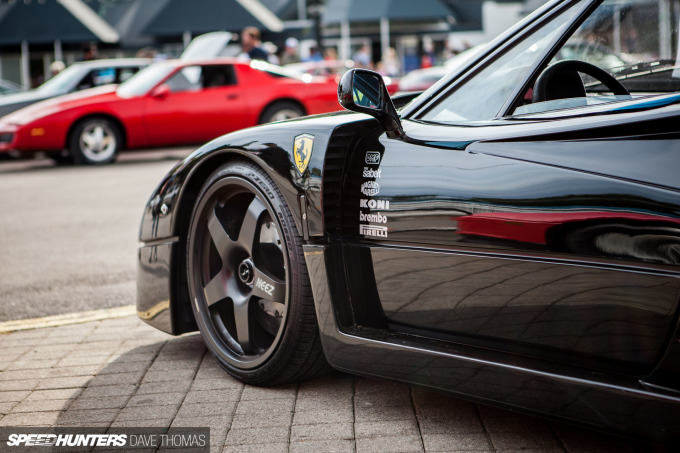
[145,64,245,145]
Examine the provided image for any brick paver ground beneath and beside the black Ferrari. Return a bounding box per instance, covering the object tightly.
[0,317,668,453]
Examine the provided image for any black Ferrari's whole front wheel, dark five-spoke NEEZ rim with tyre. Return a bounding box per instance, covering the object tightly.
[186,161,327,385]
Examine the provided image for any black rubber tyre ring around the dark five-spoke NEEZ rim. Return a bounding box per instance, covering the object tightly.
[185,161,304,384]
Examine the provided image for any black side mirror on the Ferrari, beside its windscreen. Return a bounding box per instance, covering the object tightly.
[338,69,404,138]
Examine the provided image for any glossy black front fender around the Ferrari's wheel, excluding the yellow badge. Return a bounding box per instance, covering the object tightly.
[137,113,374,335]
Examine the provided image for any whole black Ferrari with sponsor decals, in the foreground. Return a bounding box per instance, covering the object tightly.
[137,0,680,440]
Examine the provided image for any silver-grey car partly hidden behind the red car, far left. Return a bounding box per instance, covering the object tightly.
[0,58,151,116]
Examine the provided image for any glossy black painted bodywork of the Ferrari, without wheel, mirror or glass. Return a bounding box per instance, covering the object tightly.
[138,2,680,441]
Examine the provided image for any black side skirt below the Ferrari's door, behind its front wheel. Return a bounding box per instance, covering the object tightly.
[304,245,680,441]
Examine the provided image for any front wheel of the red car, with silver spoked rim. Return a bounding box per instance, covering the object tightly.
[68,117,123,165]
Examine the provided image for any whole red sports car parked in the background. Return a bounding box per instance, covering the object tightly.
[0,59,339,165]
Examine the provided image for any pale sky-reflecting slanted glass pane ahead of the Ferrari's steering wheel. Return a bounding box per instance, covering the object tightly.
[420,4,580,123]
